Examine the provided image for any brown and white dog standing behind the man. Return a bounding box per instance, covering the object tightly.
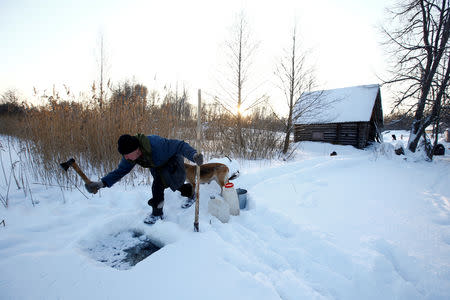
[184,163,239,193]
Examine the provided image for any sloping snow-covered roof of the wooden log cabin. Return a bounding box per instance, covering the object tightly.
[295,84,380,124]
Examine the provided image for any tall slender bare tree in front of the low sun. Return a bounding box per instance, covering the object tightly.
[215,13,267,151]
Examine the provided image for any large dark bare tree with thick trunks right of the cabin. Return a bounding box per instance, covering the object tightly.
[382,0,450,159]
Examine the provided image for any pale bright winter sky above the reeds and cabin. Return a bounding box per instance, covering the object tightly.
[0,0,390,115]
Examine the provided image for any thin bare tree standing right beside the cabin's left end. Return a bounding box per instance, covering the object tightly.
[276,26,320,154]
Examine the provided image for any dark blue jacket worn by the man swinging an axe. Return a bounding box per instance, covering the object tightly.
[101,134,197,191]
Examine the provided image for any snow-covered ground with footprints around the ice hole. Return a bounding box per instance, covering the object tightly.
[0,132,450,300]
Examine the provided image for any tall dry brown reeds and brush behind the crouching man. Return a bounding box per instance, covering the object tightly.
[0,86,281,190]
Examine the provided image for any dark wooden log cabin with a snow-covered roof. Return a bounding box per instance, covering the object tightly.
[294,84,383,149]
